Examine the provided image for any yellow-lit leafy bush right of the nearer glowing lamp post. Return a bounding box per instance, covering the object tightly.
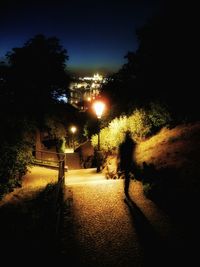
[91,103,172,152]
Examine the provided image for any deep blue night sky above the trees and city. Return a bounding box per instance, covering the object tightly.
[0,0,164,74]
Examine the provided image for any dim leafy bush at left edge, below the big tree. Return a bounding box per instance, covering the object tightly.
[0,119,34,197]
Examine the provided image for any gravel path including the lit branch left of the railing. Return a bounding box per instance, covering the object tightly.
[0,167,199,267]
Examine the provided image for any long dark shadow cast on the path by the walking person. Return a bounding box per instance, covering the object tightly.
[124,197,175,267]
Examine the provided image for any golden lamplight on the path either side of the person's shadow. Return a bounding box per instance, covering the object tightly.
[61,169,175,267]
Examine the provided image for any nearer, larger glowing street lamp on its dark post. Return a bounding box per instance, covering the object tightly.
[93,100,105,172]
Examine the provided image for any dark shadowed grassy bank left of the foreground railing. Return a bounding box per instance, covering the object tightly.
[0,183,61,262]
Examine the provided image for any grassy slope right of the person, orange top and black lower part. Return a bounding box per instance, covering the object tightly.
[135,122,200,218]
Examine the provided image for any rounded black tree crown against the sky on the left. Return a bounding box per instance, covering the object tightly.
[4,35,70,116]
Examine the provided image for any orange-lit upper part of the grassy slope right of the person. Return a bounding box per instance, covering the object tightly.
[136,122,200,169]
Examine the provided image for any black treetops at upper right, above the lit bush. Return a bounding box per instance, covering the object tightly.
[103,2,199,120]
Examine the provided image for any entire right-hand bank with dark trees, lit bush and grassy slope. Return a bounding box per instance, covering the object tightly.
[92,3,200,222]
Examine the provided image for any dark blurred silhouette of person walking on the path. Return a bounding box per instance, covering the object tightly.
[118,131,136,198]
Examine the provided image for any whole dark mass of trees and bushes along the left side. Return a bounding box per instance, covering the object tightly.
[0,35,83,196]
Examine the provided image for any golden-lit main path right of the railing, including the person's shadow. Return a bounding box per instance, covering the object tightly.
[60,169,181,267]
